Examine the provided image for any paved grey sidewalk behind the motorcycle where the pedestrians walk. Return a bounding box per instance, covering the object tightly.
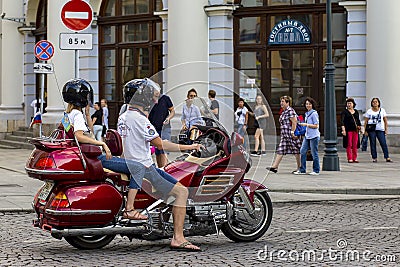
[0,149,400,211]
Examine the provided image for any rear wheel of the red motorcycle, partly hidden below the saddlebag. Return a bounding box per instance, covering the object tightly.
[65,235,115,249]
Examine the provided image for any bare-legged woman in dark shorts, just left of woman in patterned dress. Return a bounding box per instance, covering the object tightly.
[249,95,269,156]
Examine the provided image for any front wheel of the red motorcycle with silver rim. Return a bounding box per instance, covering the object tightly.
[221,192,272,242]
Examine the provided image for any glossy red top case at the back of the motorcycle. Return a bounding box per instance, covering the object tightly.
[25,145,104,181]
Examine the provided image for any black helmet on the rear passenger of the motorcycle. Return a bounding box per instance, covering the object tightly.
[63,78,93,108]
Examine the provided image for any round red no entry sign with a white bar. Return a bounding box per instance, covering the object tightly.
[61,0,93,31]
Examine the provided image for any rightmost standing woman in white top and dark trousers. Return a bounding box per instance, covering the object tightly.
[364,97,393,162]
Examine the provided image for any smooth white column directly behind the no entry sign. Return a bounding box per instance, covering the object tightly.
[42,0,75,131]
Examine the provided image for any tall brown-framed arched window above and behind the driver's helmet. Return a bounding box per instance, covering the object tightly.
[98,0,162,127]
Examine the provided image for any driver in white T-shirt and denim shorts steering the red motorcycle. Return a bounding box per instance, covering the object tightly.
[118,78,200,251]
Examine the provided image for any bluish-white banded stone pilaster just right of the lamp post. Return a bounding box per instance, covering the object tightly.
[339,1,368,111]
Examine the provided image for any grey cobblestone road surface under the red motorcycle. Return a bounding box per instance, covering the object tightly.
[0,199,400,267]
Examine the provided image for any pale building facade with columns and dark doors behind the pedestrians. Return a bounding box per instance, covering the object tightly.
[0,0,400,148]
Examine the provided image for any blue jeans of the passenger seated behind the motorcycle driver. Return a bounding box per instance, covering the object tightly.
[98,154,146,189]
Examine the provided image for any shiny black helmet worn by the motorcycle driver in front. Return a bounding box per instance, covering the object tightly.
[124,78,161,110]
